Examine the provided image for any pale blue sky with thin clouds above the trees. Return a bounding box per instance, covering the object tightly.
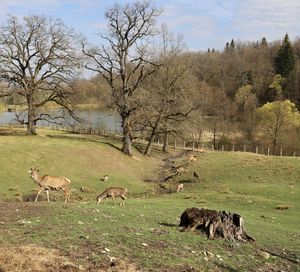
[0,0,300,51]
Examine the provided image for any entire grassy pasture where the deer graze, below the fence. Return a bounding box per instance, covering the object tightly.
[0,129,300,272]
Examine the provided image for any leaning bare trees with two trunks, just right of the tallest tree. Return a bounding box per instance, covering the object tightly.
[142,25,193,155]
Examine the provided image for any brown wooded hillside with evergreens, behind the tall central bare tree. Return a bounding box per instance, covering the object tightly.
[73,34,300,155]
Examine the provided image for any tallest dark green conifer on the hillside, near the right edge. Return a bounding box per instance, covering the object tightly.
[274,34,295,77]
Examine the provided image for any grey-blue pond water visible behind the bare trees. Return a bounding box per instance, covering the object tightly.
[0,111,121,131]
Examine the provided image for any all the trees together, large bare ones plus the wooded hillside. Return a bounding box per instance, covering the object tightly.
[0,1,300,155]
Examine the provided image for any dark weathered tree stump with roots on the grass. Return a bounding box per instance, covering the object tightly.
[179,208,255,242]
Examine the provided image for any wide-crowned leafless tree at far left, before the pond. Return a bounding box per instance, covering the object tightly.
[0,16,80,134]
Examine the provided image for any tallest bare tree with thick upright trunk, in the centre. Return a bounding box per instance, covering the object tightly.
[83,0,160,156]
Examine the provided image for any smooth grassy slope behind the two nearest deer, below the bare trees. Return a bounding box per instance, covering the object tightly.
[0,126,158,197]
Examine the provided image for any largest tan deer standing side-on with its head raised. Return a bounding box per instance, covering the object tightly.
[29,168,71,203]
